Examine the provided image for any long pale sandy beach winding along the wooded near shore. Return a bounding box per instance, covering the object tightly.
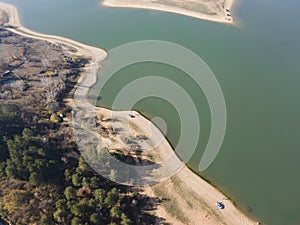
[0,1,257,225]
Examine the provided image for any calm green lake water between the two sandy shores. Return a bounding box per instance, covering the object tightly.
[5,0,300,225]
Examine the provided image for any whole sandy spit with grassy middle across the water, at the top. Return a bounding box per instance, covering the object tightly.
[102,0,235,24]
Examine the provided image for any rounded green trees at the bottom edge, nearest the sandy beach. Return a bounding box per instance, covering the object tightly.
[54,158,133,225]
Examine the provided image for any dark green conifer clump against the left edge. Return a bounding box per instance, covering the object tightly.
[0,104,63,185]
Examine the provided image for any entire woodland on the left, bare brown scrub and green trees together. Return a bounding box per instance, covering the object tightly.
[0,29,155,225]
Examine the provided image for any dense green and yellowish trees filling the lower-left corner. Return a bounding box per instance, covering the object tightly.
[0,104,136,225]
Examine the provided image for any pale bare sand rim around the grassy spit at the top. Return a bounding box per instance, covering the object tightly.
[101,0,235,24]
